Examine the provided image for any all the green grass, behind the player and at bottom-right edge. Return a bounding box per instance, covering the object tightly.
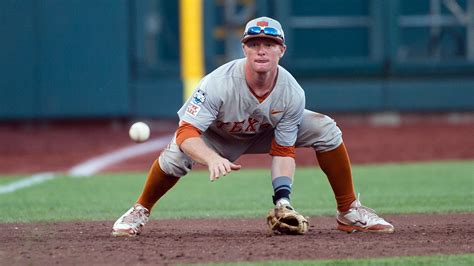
[0,161,474,265]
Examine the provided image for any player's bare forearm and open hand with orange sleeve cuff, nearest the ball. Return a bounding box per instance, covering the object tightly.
[176,121,241,181]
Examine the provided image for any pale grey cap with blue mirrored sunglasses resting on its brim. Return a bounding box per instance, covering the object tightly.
[240,17,285,45]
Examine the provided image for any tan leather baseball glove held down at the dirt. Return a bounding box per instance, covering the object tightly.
[267,205,309,235]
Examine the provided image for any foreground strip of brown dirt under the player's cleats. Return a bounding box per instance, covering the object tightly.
[0,214,474,265]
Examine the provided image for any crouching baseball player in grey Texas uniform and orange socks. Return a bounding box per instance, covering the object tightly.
[112,17,394,236]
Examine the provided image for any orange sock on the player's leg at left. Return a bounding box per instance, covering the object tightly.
[137,160,179,211]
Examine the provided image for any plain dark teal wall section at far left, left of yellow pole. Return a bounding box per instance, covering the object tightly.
[0,0,129,118]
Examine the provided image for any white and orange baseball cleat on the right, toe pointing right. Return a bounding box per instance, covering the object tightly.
[337,199,395,233]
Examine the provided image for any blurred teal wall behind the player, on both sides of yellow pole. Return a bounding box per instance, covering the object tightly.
[0,0,474,120]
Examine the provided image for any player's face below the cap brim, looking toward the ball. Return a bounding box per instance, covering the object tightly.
[243,38,285,73]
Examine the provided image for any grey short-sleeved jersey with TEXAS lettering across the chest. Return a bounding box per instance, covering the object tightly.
[178,58,305,149]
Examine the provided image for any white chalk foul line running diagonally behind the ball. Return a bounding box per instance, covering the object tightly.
[0,135,173,195]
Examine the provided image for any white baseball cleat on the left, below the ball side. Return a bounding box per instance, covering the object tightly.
[112,203,150,237]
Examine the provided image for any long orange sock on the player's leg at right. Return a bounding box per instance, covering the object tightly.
[316,143,356,212]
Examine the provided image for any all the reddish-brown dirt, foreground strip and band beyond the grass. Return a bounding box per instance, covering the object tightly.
[0,115,474,265]
